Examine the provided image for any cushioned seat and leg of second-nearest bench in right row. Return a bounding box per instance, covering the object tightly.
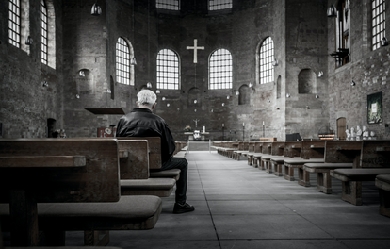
[330,168,390,206]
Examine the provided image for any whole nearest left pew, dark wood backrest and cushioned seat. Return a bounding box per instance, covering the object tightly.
[0,139,162,246]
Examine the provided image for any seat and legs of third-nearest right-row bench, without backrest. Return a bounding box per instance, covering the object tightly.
[299,163,353,194]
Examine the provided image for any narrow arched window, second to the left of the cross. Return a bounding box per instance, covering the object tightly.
[116,37,130,85]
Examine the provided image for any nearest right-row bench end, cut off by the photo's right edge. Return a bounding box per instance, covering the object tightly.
[375,174,390,217]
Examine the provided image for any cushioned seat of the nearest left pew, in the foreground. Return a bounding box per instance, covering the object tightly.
[0,195,162,245]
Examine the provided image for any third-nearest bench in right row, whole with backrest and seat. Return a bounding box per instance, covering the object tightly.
[299,141,362,194]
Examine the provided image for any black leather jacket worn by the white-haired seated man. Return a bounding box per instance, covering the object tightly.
[116,108,175,163]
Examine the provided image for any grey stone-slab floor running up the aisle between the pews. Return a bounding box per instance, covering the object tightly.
[62,145,390,249]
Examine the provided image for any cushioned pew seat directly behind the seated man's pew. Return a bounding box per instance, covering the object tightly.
[121,178,176,197]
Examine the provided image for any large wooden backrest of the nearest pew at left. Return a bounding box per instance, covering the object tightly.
[0,138,121,202]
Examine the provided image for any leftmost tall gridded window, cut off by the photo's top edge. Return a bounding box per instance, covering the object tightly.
[8,0,21,48]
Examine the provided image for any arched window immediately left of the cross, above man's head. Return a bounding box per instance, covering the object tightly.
[156,49,180,90]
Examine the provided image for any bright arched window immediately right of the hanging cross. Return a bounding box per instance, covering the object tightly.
[209,48,233,90]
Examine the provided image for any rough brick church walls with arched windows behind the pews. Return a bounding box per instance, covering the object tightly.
[0,0,390,141]
